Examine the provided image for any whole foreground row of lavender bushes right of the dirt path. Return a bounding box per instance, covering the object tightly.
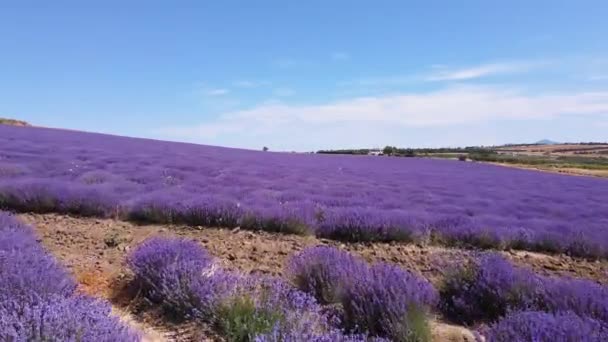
[128,238,608,342]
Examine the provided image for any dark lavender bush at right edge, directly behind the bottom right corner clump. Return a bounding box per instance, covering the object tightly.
[440,254,608,324]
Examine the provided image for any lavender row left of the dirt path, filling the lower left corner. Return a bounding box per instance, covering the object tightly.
[0,212,140,342]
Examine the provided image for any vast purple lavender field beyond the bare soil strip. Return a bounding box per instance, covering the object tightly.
[0,126,608,258]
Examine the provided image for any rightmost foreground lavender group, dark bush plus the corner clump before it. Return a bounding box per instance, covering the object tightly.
[440,254,608,341]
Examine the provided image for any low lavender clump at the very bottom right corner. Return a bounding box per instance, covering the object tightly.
[481,311,608,342]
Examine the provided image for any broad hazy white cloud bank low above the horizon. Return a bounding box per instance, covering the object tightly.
[158,86,608,146]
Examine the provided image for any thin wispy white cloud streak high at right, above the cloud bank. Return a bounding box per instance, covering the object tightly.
[426,62,539,81]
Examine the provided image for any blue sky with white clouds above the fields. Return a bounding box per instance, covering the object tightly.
[0,0,608,151]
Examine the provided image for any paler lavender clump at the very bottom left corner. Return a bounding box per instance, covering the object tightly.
[0,296,141,342]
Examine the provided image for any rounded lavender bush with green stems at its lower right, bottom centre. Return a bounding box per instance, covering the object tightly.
[342,263,438,341]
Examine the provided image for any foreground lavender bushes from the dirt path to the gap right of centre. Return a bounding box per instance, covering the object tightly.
[128,238,438,342]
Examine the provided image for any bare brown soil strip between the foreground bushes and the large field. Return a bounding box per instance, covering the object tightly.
[19,214,608,341]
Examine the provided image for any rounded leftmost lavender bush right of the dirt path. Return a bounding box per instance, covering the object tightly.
[127,238,213,318]
